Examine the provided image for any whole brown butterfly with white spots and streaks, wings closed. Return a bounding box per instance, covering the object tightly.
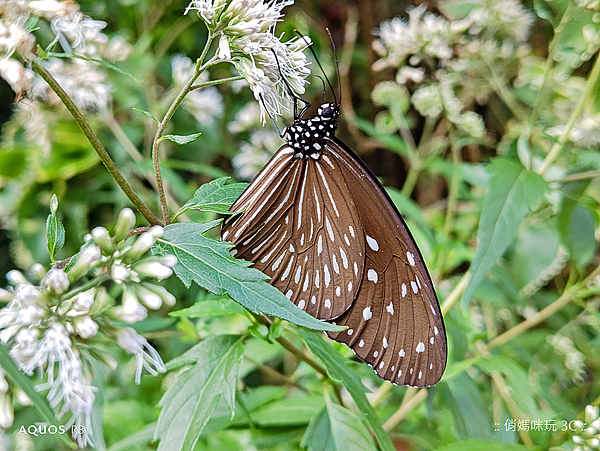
[221,43,447,387]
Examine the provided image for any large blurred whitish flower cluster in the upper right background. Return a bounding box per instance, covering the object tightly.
[373,0,534,138]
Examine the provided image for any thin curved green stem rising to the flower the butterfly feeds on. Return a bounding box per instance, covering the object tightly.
[152,32,214,225]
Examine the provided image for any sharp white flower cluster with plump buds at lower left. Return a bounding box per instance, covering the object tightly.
[0,209,176,446]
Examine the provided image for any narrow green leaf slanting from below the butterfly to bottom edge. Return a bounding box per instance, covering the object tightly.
[300,331,396,451]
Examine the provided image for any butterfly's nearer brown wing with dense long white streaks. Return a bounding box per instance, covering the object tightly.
[222,146,365,320]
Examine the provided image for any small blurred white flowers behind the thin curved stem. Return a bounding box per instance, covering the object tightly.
[171,54,223,125]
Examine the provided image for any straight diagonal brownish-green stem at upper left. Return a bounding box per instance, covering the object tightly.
[33,60,160,225]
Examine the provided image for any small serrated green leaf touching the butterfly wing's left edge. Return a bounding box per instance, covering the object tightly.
[173,177,248,219]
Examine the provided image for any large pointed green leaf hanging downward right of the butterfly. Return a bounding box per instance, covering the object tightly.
[461,158,548,308]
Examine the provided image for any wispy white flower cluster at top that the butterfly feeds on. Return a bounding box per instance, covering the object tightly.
[185,0,310,123]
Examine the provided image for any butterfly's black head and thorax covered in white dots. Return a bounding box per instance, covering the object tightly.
[283,103,340,160]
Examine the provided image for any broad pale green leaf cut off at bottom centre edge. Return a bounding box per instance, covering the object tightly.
[300,398,377,451]
